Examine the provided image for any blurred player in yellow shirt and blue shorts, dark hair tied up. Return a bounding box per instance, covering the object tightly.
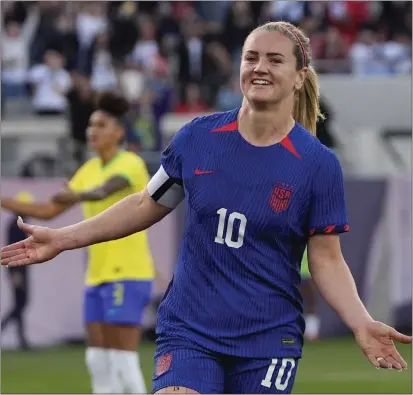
[1,93,154,394]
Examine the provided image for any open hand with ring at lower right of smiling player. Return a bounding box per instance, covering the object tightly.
[354,321,412,370]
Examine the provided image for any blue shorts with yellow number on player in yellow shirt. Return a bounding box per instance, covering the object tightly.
[83,280,152,325]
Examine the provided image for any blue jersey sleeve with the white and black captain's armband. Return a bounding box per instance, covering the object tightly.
[148,121,194,209]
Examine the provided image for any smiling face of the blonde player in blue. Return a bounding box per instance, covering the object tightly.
[240,30,306,105]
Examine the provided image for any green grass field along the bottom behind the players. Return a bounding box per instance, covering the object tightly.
[1,338,412,394]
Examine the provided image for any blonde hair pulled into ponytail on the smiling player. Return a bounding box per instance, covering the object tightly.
[245,21,324,136]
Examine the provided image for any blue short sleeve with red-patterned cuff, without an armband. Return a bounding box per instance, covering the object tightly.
[308,151,350,236]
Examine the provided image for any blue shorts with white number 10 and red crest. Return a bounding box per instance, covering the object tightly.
[152,338,299,394]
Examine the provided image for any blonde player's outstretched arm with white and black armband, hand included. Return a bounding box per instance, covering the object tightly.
[1,168,180,266]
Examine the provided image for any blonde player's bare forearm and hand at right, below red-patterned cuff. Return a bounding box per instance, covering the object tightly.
[308,235,412,370]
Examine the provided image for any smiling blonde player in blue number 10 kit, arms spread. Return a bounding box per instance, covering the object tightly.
[2,22,411,394]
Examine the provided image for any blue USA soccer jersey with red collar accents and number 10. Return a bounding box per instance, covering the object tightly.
[148,109,349,358]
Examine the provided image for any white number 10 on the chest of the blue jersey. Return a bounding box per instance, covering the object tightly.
[215,208,247,248]
